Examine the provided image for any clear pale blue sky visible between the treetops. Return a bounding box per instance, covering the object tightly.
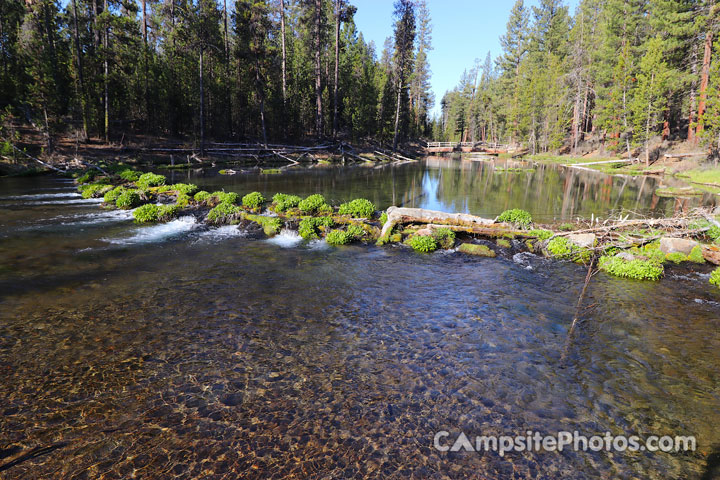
[353,0,578,118]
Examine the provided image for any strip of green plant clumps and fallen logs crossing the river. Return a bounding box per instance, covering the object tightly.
[77,168,720,284]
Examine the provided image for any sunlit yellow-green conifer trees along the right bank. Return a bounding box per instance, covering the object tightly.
[434,0,720,162]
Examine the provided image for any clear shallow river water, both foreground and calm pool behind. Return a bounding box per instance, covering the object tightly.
[0,159,720,479]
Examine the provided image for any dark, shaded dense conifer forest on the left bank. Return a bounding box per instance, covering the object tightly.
[0,0,433,146]
